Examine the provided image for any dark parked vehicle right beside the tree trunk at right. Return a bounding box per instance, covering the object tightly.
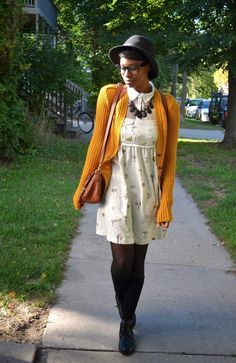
[209,92,228,128]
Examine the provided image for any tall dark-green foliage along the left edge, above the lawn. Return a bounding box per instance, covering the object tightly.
[0,0,33,159]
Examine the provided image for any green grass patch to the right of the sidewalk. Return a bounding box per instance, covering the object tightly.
[177,140,236,260]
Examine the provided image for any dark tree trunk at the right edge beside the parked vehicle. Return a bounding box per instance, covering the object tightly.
[223,69,236,147]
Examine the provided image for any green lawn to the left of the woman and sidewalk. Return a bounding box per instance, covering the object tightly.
[0,137,87,306]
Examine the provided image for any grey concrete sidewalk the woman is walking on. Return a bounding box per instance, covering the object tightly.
[38,181,236,363]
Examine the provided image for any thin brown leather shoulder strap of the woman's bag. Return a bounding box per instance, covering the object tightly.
[98,83,126,169]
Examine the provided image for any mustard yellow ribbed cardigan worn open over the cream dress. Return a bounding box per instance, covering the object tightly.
[73,85,180,222]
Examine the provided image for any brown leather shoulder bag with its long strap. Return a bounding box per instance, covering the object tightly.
[79,84,125,206]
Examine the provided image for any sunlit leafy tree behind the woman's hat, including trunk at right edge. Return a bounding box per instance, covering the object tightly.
[53,0,236,144]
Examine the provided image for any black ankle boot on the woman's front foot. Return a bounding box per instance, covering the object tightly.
[118,320,135,355]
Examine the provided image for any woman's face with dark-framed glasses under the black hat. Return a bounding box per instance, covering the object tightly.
[120,57,150,92]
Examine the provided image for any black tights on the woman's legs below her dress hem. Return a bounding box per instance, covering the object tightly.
[111,243,148,320]
